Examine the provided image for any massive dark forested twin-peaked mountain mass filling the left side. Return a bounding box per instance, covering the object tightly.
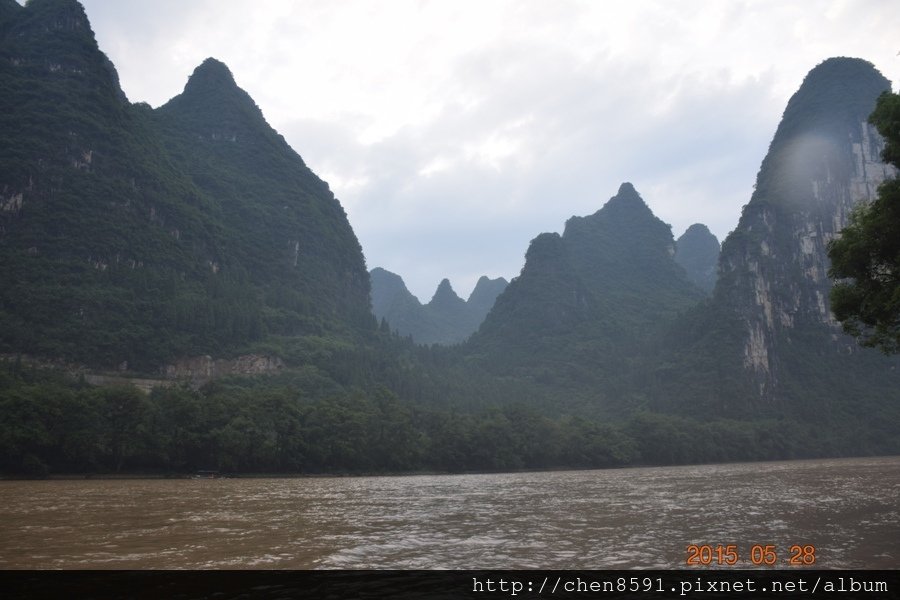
[0,0,374,372]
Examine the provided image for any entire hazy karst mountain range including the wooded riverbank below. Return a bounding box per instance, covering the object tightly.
[0,0,900,473]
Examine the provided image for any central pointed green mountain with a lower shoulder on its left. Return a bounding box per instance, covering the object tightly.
[468,183,704,397]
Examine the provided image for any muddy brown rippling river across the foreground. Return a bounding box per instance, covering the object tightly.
[0,457,900,569]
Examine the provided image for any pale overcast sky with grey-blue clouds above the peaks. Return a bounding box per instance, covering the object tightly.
[68,0,900,302]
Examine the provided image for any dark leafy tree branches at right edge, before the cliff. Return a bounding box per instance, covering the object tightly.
[828,92,900,354]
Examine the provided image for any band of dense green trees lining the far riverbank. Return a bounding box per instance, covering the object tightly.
[0,356,900,477]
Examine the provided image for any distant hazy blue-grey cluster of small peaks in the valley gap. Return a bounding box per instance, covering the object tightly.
[369,267,507,345]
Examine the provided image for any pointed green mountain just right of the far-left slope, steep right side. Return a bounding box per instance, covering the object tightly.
[156,59,369,335]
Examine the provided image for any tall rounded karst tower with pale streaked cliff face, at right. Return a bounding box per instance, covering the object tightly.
[716,58,893,403]
